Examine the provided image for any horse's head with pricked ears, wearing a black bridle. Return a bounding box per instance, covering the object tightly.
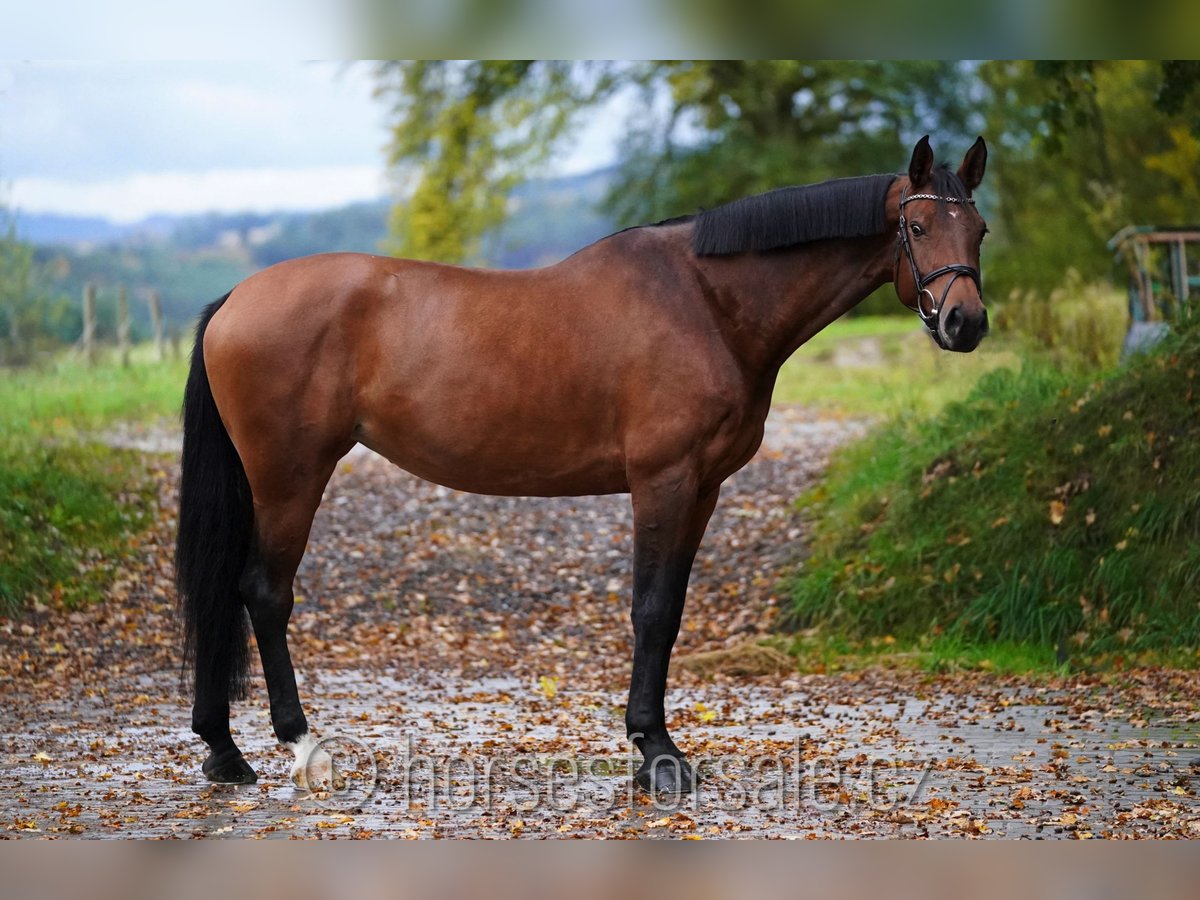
[893,134,988,353]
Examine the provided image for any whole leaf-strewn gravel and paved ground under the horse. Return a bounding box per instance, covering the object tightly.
[0,409,1200,838]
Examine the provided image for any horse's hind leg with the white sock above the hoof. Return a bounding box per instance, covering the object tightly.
[241,454,338,786]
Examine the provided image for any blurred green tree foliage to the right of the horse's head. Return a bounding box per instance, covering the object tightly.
[978,60,1200,296]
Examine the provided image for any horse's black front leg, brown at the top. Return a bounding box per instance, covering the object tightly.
[625,470,720,793]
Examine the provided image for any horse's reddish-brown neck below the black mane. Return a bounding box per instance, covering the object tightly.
[702,235,894,383]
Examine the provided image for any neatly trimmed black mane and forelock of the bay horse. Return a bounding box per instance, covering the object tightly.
[691,169,897,256]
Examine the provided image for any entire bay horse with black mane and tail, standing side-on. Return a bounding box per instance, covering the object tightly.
[175,136,988,792]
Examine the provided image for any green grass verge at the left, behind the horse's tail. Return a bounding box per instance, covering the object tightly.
[0,352,185,614]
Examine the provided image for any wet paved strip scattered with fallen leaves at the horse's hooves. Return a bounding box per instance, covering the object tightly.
[0,672,1200,838]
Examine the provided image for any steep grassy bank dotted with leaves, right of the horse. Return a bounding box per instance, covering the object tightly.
[791,331,1200,667]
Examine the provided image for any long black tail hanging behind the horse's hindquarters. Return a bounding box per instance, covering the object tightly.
[175,294,254,702]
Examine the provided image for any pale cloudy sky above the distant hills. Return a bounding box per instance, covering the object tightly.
[0,62,619,222]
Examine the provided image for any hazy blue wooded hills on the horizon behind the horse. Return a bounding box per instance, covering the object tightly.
[17,169,616,334]
